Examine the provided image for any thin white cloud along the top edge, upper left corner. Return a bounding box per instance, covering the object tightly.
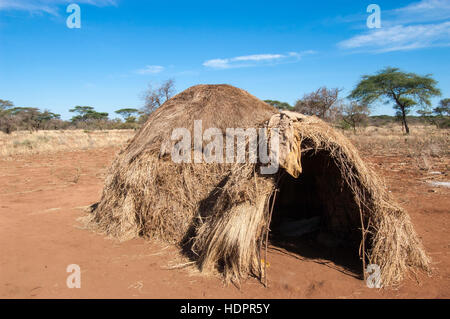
[0,0,117,15]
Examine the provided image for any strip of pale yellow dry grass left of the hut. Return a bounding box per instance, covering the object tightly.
[0,130,135,157]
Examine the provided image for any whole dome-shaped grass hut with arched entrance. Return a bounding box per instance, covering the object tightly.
[85,85,429,285]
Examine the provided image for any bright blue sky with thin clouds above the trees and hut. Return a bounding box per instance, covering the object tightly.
[0,0,450,119]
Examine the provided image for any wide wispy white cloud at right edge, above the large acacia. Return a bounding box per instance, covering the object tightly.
[338,21,450,52]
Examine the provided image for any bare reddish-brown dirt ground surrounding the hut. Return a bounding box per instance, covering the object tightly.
[0,149,450,298]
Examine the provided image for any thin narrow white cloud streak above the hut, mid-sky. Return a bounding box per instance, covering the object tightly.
[203,50,314,69]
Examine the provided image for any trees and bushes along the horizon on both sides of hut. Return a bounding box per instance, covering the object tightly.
[0,67,450,134]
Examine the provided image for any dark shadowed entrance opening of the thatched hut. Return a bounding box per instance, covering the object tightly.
[270,151,361,274]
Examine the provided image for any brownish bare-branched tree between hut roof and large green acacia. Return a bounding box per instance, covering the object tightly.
[294,86,341,120]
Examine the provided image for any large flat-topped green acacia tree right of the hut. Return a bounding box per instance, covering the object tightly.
[349,67,441,134]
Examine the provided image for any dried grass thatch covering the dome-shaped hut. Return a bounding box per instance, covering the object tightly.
[82,85,429,286]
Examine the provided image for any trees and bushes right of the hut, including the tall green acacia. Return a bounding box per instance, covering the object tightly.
[265,67,450,134]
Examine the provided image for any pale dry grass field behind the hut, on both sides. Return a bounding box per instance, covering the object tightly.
[0,124,450,162]
